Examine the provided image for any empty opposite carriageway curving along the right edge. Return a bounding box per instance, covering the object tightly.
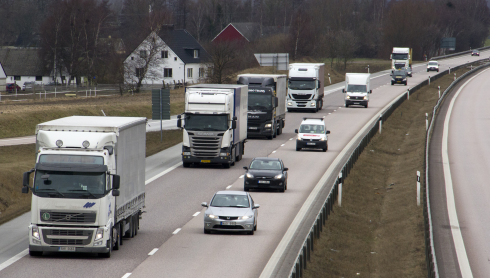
[429,65,490,277]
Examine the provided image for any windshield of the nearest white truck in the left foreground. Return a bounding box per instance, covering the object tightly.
[34,170,106,199]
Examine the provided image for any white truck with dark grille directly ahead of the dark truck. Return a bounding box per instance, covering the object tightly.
[177,84,248,168]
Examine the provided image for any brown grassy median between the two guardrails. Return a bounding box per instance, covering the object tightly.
[304,64,480,278]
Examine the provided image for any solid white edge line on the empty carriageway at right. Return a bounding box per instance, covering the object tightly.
[442,69,488,278]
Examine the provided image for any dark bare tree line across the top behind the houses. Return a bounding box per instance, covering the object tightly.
[0,0,490,83]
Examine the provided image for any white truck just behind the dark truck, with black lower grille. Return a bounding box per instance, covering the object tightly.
[287,63,325,112]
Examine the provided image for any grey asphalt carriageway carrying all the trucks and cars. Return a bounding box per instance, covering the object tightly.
[0,51,490,278]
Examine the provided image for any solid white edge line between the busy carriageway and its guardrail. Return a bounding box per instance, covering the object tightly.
[259,76,424,278]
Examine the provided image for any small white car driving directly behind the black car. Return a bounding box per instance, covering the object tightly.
[294,118,330,152]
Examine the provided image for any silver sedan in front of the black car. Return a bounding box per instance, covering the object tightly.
[201,191,260,235]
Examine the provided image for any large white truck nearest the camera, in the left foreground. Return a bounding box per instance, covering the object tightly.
[22,116,146,257]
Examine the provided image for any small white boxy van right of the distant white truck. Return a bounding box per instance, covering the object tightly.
[342,73,373,108]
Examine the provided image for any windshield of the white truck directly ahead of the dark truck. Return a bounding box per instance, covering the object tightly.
[185,114,228,131]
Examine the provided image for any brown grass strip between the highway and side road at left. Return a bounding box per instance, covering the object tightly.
[0,130,182,224]
